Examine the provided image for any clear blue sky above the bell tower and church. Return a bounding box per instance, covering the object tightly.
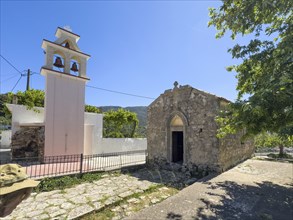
[0,1,244,106]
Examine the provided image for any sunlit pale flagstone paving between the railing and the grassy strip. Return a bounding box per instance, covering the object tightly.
[0,174,157,220]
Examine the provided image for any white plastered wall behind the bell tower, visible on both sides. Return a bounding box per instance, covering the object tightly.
[5,104,147,155]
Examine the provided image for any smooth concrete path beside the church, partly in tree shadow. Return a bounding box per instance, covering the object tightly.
[127,160,293,220]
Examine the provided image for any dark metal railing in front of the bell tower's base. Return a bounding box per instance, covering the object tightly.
[0,150,147,179]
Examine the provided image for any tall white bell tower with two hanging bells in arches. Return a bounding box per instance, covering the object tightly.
[41,27,90,156]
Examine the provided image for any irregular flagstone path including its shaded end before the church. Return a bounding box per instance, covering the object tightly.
[0,168,196,220]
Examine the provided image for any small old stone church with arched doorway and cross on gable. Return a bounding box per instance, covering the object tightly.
[147,82,254,172]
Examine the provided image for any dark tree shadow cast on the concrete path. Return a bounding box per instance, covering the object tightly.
[193,181,293,220]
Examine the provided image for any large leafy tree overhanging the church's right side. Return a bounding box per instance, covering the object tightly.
[209,0,293,154]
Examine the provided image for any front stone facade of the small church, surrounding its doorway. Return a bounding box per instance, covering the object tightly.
[147,86,219,173]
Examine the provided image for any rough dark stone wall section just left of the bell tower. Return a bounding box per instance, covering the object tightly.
[11,126,45,160]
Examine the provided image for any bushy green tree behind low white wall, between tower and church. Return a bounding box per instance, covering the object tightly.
[103,108,138,138]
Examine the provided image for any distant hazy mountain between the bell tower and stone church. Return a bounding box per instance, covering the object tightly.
[98,106,147,127]
